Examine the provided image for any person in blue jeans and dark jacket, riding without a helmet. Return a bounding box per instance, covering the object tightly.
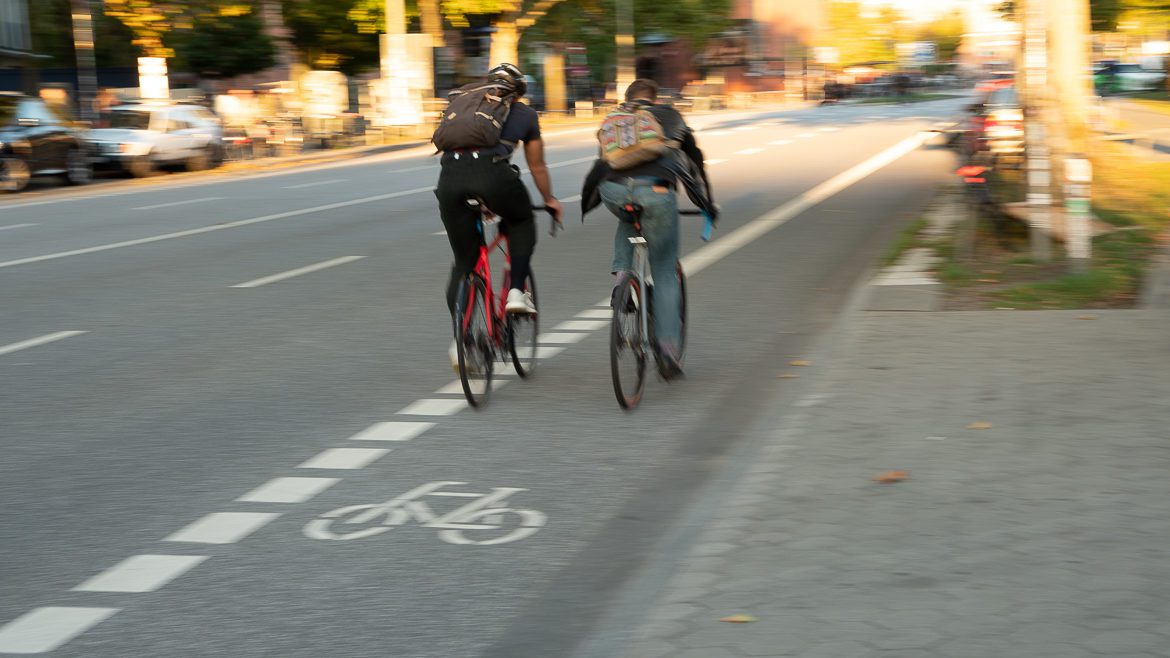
[581,78,718,379]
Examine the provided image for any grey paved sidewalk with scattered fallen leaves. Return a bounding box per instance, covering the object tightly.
[610,309,1170,658]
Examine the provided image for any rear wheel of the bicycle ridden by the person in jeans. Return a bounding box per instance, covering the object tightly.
[610,273,646,409]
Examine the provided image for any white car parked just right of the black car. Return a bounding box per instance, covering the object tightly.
[89,102,223,177]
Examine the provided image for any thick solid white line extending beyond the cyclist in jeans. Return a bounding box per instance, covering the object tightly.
[681,132,928,275]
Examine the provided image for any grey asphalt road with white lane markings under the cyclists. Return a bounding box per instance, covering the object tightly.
[0,101,961,658]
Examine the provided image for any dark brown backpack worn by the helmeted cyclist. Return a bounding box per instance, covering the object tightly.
[431,82,516,151]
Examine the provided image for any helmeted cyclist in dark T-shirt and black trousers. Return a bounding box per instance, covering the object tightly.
[435,64,562,366]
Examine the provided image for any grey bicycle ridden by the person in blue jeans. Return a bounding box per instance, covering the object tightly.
[610,204,713,409]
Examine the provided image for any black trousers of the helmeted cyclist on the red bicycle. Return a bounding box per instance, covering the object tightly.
[435,153,536,313]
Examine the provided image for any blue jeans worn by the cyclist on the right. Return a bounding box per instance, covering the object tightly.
[600,179,682,347]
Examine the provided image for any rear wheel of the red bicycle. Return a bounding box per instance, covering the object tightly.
[455,275,494,407]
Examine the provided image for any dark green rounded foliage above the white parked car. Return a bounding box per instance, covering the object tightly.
[174,13,276,78]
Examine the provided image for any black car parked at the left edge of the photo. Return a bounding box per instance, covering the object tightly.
[0,92,94,192]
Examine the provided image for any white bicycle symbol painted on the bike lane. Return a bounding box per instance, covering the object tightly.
[304,481,545,546]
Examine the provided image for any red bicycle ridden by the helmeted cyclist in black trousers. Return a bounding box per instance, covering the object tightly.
[455,197,558,407]
